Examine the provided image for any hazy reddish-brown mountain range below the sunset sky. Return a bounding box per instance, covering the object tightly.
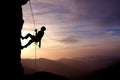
[22,56,120,80]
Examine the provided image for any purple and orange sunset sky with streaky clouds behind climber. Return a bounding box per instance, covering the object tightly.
[22,0,120,59]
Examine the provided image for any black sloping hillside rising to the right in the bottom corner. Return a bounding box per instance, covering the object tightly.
[85,62,120,80]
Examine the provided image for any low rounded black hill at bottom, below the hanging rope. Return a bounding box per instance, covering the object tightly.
[23,72,69,80]
